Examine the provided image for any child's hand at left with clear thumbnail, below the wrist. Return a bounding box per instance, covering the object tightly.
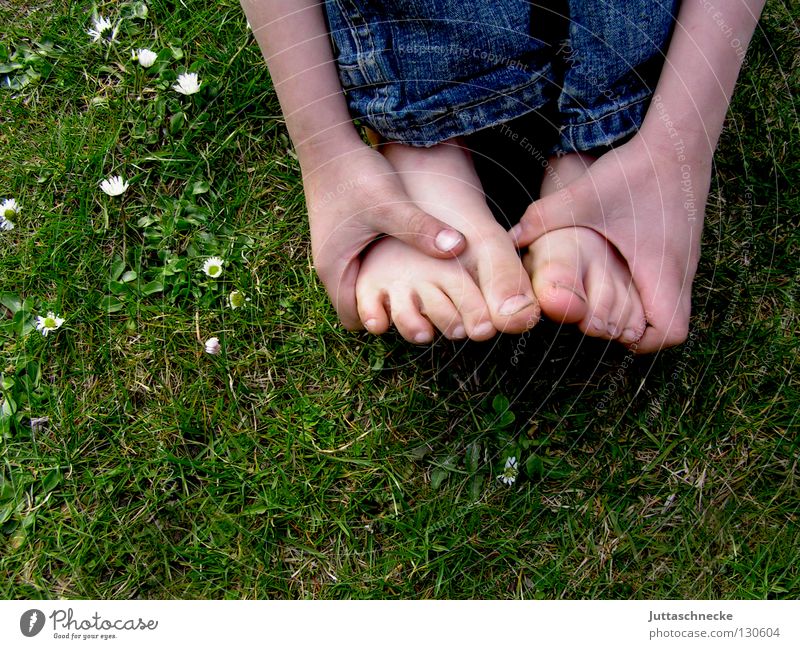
[303,144,466,329]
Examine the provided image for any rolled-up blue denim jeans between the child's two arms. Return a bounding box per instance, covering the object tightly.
[325,0,679,152]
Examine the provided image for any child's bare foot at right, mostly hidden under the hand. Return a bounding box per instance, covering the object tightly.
[523,154,645,344]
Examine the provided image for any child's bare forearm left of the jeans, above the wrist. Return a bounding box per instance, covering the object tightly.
[241,0,361,170]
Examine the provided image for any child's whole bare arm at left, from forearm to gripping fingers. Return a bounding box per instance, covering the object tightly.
[242,0,465,329]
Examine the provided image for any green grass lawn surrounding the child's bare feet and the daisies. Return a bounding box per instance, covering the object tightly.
[0,0,800,599]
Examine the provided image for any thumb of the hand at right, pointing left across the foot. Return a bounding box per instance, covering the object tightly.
[509,179,600,248]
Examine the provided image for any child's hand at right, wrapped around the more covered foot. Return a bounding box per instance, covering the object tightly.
[511,135,711,353]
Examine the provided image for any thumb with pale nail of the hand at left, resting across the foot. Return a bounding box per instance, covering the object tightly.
[373,201,467,258]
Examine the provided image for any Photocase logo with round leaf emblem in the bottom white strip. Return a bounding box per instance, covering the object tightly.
[19,608,158,640]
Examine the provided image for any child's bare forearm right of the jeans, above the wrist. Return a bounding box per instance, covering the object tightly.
[640,0,765,162]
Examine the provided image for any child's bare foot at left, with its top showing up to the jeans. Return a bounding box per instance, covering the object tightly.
[356,141,539,343]
